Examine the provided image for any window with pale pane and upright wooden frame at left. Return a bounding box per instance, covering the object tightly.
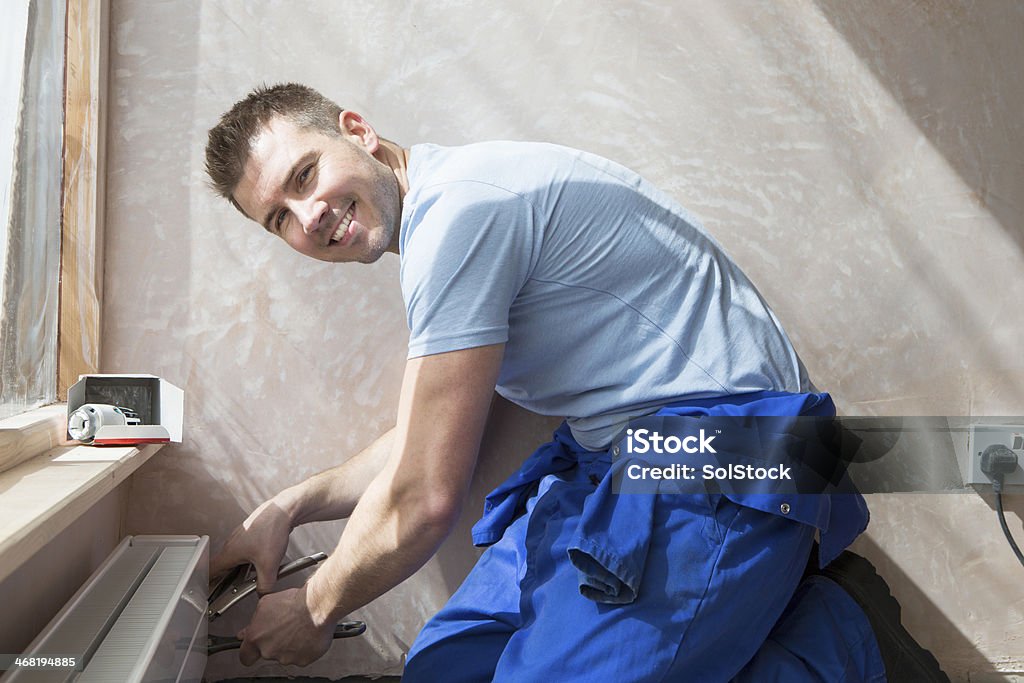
[0,0,102,421]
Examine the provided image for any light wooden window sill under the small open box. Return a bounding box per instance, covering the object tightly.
[0,405,163,581]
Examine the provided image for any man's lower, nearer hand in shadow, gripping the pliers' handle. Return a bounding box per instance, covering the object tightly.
[239,587,336,667]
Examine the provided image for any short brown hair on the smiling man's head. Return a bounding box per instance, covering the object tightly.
[206,83,341,208]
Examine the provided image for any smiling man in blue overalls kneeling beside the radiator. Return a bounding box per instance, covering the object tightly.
[201,84,942,681]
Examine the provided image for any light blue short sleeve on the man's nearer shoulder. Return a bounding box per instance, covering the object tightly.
[401,180,540,358]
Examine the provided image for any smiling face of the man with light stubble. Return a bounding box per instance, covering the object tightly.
[232,113,401,263]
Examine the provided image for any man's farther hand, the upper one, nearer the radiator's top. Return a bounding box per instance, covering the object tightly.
[210,500,292,595]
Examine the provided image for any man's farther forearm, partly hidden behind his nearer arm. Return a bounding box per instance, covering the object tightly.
[273,428,394,527]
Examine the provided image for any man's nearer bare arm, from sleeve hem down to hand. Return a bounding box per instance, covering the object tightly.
[233,344,505,665]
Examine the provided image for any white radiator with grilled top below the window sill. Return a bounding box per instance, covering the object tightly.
[0,536,210,683]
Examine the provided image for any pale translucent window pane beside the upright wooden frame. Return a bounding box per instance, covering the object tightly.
[0,0,66,418]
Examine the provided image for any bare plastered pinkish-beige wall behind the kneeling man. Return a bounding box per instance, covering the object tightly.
[102,0,1024,680]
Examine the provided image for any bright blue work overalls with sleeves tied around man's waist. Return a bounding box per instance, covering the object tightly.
[402,392,886,683]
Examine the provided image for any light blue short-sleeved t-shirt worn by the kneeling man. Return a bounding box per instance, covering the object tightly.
[400,142,811,450]
